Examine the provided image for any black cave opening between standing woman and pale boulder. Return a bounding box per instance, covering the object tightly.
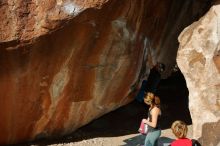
[158,70,192,128]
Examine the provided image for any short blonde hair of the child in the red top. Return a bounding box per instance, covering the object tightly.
[171,120,188,139]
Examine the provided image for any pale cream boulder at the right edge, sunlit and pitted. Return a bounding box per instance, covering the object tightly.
[177,5,220,146]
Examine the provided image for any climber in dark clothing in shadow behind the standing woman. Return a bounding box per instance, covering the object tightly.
[136,62,165,102]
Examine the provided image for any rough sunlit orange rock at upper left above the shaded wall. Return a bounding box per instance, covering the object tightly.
[0,0,108,42]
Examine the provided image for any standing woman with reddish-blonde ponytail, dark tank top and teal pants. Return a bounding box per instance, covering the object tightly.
[143,92,161,146]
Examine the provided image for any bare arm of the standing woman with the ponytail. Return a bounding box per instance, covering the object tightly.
[143,107,160,128]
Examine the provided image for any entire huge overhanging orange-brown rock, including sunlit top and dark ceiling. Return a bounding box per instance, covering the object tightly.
[0,0,213,144]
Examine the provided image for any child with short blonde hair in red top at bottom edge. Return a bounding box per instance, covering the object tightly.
[171,121,192,146]
